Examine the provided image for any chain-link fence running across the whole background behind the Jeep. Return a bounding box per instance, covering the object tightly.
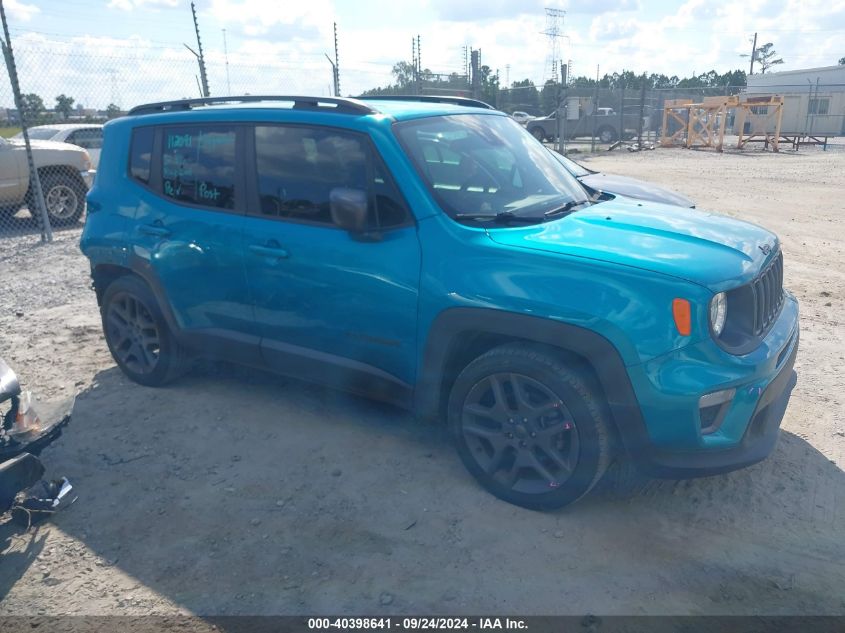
[0,24,845,240]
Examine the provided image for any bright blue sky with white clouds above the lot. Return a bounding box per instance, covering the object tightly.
[0,0,845,107]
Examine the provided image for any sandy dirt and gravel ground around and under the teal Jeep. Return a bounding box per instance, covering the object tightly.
[0,148,845,615]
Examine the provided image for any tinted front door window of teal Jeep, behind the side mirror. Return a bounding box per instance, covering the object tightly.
[255,125,407,228]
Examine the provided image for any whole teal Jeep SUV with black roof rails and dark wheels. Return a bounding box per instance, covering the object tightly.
[81,97,798,509]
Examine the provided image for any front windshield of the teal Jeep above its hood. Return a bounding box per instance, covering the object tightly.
[395,114,588,218]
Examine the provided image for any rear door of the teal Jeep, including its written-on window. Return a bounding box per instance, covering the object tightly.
[130,123,259,362]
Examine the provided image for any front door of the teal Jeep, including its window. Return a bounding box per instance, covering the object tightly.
[244,125,420,400]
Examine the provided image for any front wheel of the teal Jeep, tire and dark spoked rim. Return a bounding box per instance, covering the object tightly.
[448,343,612,510]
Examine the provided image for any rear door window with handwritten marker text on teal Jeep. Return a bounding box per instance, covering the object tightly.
[161,125,237,209]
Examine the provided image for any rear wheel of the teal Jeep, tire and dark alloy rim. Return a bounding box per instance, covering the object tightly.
[100,275,187,387]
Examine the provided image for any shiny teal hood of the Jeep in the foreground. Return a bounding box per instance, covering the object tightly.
[488,197,780,291]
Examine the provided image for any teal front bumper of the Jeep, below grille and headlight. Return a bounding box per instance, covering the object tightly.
[623,293,799,479]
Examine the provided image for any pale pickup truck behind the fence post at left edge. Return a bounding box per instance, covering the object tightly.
[0,138,95,226]
